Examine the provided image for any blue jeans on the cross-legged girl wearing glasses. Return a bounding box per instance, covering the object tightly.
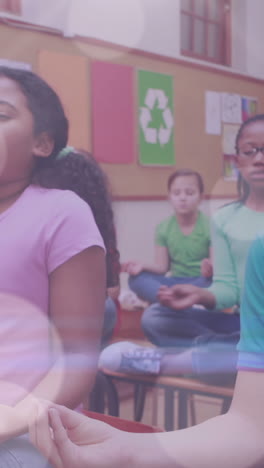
[142,304,240,376]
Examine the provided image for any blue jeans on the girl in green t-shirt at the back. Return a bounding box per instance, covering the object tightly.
[128,271,212,304]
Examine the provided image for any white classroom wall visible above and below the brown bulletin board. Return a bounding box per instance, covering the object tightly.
[13,0,264,288]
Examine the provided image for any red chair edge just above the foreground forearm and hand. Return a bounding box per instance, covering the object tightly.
[83,410,164,433]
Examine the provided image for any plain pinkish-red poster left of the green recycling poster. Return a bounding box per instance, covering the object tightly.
[91,61,136,164]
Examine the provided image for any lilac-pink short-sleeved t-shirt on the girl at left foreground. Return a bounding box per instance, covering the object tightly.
[0,186,104,404]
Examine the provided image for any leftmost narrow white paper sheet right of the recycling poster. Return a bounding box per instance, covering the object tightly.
[205,91,221,135]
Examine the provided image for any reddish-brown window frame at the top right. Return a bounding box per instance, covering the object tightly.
[180,0,231,66]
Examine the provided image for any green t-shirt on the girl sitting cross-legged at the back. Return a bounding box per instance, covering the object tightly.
[155,211,210,277]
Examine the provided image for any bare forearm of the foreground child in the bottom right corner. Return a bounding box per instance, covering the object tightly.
[129,412,264,468]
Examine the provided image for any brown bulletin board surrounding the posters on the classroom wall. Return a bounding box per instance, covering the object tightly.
[0,25,264,200]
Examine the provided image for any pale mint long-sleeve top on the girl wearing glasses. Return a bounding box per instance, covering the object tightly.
[208,202,264,309]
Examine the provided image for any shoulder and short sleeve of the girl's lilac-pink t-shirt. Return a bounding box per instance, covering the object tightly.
[32,187,104,274]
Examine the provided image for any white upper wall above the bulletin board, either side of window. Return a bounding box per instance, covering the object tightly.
[22,0,264,78]
